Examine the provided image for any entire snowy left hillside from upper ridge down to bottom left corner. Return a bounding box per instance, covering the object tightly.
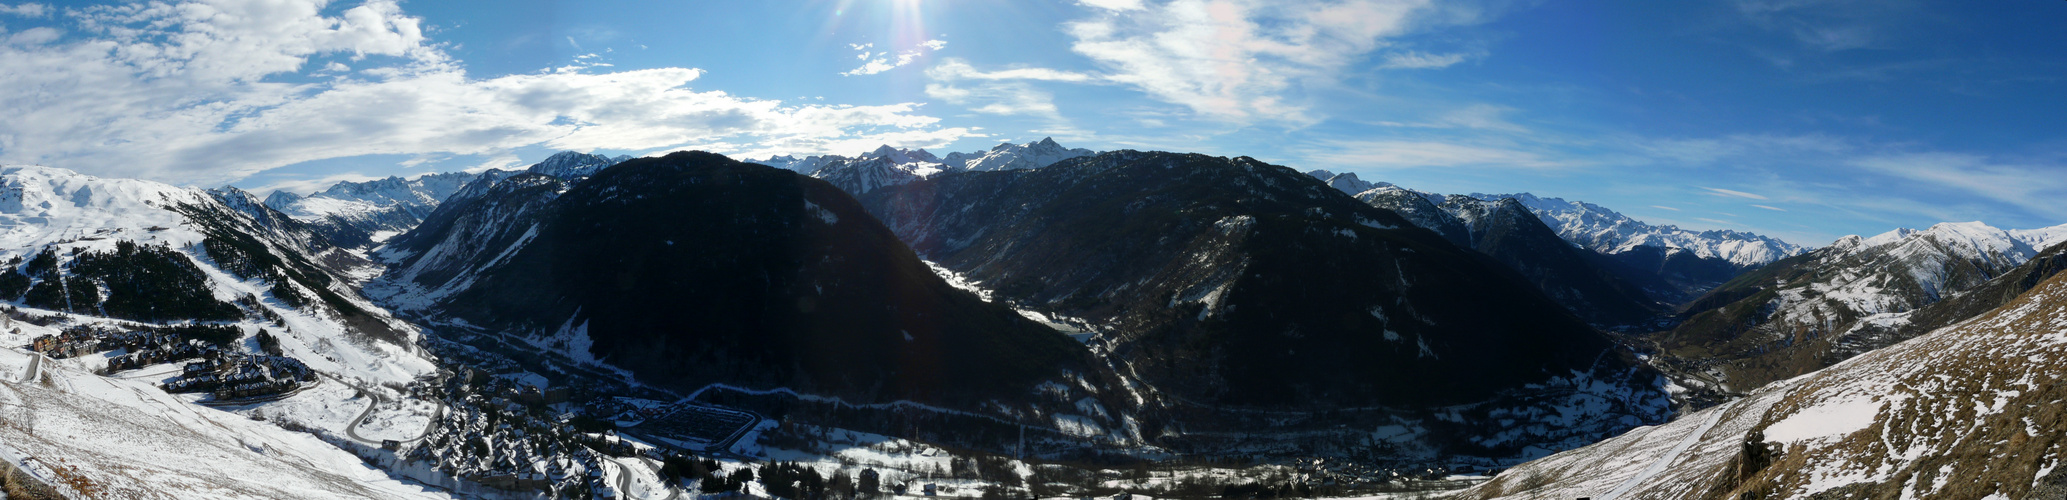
[0,165,436,498]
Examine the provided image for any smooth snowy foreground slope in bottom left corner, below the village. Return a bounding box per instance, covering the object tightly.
[0,349,449,498]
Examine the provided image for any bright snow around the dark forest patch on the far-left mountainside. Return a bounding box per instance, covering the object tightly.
[0,165,434,382]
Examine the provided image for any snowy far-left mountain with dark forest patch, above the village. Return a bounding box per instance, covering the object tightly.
[0,165,432,382]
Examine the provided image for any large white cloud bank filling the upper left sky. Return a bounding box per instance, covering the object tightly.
[0,0,976,186]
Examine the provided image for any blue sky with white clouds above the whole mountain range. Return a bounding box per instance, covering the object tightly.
[0,0,2067,246]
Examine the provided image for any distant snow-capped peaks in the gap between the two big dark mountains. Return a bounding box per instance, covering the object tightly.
[746,138,1093,196]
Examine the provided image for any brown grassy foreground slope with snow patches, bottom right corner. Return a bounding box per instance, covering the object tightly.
[1453,268,2067,498]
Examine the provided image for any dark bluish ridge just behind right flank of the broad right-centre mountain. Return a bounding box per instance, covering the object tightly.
[1364,185,1664,326]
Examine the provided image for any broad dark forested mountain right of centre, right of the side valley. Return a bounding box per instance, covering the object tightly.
[862,151,1666,461]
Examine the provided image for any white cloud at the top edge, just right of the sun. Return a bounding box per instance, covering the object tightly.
[1065,0,1472,122]
